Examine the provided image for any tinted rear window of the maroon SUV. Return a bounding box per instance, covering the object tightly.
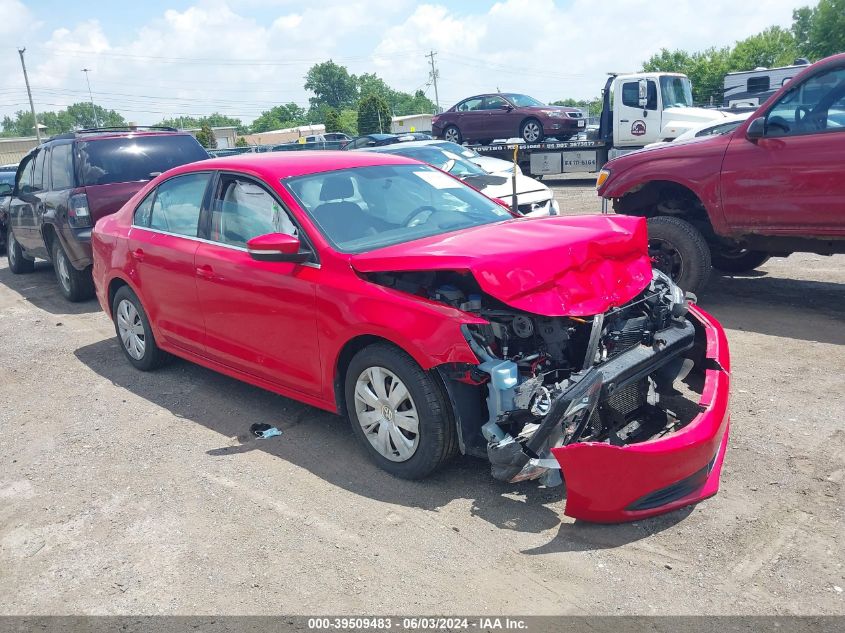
[77,134,208,185]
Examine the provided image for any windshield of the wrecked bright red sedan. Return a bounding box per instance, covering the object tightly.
[282,165,513,253]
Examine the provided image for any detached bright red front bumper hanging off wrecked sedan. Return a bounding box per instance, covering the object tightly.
[551,306,730,523]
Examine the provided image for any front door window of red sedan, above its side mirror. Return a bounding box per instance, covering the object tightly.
[211,174,297,247]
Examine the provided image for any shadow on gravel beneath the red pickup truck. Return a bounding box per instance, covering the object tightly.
[699,271,845,345]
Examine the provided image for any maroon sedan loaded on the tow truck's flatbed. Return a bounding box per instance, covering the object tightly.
[431,92,586,145]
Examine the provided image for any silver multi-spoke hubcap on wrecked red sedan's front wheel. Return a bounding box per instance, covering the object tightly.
[355,367,420,462]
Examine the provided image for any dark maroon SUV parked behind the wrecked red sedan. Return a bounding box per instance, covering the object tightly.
[7,128,209,301]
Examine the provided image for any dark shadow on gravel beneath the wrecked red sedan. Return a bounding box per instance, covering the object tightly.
[75,339,684,553]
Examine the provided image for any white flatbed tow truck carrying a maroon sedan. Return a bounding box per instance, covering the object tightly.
[472,72,728,176]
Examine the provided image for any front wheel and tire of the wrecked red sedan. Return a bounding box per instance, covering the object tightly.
[344,344,456,479]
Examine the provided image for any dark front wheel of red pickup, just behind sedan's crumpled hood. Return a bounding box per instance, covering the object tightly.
[648,216,711,293]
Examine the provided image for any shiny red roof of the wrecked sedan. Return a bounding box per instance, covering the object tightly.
[163,150,419,182]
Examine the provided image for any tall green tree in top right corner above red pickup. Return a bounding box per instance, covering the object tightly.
[792,0,845,60]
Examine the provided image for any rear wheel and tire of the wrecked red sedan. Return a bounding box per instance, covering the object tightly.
[112,286,167,371]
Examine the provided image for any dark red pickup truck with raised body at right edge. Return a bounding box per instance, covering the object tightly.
[597,54,845,292]
